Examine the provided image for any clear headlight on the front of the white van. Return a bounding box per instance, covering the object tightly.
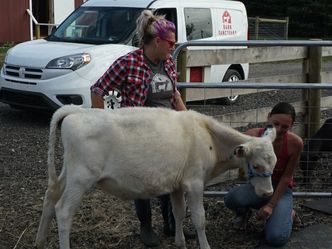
[46,53,91,71]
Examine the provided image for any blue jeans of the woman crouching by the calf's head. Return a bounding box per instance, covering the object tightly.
[224,183,293,246]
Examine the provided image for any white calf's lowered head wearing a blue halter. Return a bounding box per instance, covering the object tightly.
[234,128,277,197]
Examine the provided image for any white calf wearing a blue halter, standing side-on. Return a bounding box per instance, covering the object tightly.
[36,106,276,249]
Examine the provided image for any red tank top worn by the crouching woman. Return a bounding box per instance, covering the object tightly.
[258,128,294,188]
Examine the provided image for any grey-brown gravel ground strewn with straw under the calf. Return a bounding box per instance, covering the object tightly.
[0,90,332,249]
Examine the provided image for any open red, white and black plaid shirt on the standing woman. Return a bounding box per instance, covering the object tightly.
[90,49,178,108]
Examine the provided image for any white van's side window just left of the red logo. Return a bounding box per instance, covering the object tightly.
[184,8,212,41]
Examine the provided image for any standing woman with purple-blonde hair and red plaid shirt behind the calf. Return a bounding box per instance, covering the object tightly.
[90,10,186,246]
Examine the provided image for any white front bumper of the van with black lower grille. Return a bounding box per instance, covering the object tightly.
[0,68,91,110]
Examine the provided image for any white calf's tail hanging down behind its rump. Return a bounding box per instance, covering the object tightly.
[47,105,84,187]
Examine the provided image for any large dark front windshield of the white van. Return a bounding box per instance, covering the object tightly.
[46,7,143,44]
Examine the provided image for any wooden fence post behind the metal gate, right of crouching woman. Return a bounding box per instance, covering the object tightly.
[306,41,322,138]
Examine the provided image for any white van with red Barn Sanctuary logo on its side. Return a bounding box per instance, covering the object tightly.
[0,0,249,110]
